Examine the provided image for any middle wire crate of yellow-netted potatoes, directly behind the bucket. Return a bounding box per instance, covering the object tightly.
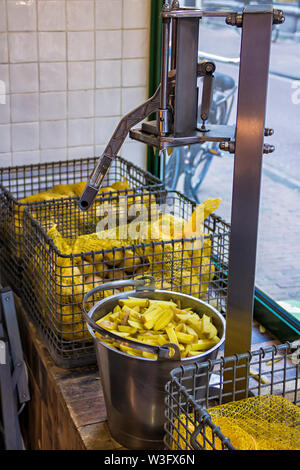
[22,189,230,367]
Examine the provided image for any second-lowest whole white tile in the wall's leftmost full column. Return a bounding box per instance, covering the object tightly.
[11,93,39,122]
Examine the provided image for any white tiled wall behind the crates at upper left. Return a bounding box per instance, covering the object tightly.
[0,0,150,167]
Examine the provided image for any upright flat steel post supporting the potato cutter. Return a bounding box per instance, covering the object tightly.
[225,5,273,356]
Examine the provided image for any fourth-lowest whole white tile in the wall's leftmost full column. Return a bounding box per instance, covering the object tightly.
[8,33,37,63]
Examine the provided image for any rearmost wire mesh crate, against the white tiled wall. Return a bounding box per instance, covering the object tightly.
[0,157,162,293]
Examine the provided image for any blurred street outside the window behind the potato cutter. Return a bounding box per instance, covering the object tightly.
[164,10,300,308]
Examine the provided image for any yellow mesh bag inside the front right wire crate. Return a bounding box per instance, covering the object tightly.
[173,395,300,450]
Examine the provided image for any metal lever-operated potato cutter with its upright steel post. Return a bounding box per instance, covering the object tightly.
[79,0,284,356]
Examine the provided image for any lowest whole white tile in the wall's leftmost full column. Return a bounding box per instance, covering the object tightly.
[11,122,39,152]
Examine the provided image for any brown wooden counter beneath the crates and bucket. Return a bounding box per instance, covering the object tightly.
[15,297,279,450]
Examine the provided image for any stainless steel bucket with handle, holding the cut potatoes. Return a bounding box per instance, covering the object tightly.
[83,276,225,450]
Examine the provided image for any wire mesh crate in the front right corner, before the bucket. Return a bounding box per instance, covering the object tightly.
[164,341,300,450]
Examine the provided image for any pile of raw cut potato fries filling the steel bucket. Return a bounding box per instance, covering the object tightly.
[96,297,220,359]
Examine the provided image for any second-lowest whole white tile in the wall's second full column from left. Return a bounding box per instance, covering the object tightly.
[40,92,67,121]
